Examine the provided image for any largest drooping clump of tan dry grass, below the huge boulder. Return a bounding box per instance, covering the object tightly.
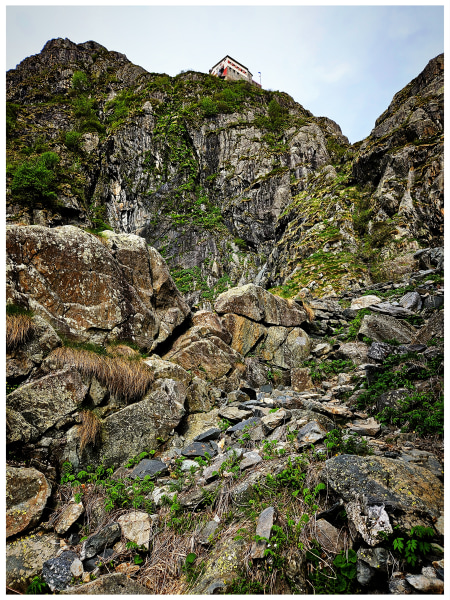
[52,346,153,402]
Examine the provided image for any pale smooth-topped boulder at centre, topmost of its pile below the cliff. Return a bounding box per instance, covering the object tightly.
[214,283,307,327]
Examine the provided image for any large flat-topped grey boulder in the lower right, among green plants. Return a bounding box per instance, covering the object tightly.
[322,454,444,545]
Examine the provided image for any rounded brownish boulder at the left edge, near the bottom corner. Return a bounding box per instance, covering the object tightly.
[6,466,52,538]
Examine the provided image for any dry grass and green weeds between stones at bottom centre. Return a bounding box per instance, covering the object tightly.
[55,438,355,594]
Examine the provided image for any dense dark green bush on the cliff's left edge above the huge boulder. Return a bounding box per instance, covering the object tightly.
[11,152,59,204]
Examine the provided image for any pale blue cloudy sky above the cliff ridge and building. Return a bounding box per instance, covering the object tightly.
[6,2,444,143]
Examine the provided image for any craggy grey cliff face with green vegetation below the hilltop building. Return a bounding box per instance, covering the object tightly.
[7,39,443,303]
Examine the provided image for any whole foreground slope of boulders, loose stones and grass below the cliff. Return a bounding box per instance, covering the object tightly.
[6,226,444,594]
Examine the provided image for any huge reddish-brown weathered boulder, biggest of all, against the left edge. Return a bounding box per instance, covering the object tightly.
[6,225,189,348]
